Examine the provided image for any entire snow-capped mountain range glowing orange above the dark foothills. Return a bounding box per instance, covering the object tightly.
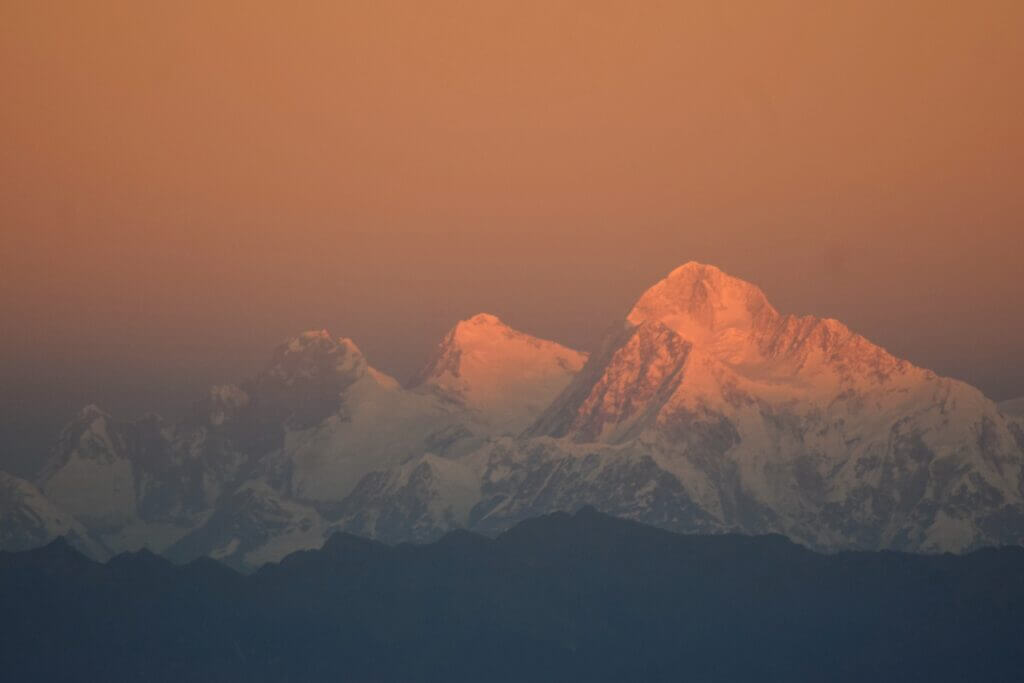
[0,262,1024,570]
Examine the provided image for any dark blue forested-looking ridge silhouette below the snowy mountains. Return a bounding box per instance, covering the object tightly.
[0,508,1024,682]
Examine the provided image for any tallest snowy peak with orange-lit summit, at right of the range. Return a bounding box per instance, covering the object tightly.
[520,263,1024,551]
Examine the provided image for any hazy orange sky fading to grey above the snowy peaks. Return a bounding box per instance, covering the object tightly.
[0,0,1024,467]
